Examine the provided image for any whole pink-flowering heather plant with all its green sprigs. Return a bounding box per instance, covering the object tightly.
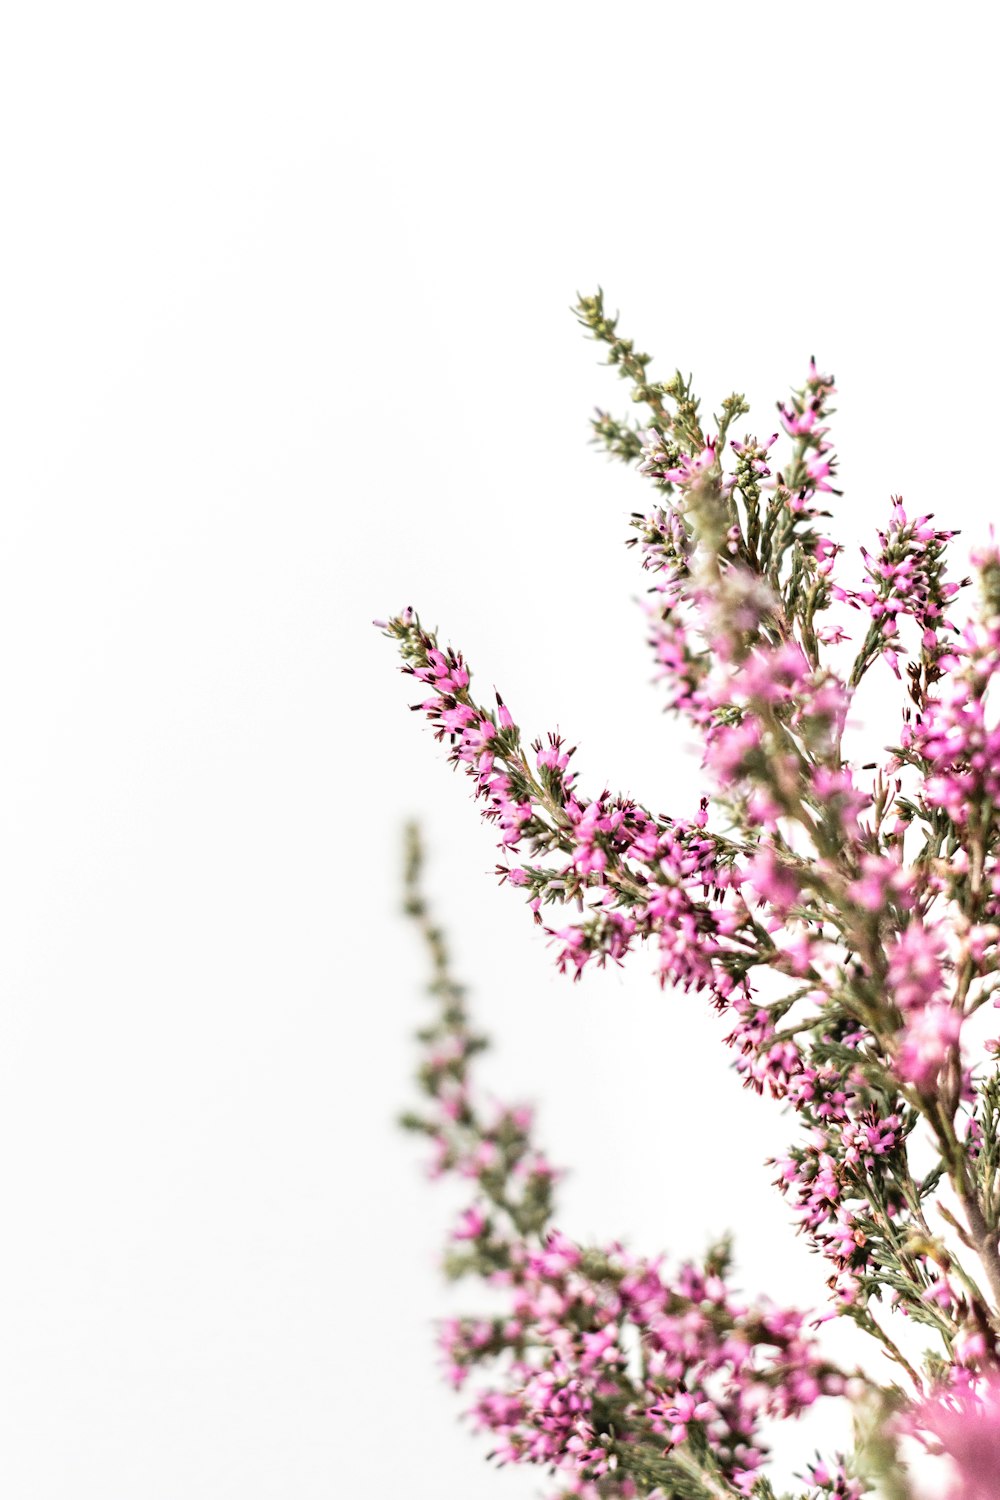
[384,293,1000,1500]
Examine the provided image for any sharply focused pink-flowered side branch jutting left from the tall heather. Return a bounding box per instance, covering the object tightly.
[388,611,756,1001]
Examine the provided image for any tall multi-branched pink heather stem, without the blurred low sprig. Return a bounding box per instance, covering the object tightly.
[385,293,1000,1482]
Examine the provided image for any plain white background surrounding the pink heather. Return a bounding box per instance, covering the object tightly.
[0,0,997,1500]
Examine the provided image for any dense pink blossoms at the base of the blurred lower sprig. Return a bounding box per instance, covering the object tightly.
[458,1235,844,1493]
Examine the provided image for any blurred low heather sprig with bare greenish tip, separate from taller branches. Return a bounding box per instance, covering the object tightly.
[403,828,868,1500]
